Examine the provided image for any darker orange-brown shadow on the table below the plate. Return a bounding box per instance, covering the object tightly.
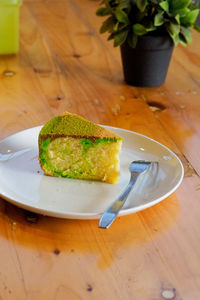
[0,194,180,269]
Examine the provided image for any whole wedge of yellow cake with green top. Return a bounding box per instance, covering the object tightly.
[39,112,122,183]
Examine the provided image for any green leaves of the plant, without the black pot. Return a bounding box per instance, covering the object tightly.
[96,0,200,48]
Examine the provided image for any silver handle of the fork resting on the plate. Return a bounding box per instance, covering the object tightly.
[99,173,140,228]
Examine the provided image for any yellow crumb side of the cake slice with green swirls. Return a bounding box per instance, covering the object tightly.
[41,137,122,183]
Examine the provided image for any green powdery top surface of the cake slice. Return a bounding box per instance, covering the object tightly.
[39,112,122,142]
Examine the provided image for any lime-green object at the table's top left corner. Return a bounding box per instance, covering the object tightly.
[0,0,21,54]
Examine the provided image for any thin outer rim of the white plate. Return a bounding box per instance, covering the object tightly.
[0,124,184,220]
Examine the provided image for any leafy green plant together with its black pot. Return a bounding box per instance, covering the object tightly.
[96,0,200,86]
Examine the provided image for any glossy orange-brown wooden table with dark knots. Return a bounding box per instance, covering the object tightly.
[0,0,200,300]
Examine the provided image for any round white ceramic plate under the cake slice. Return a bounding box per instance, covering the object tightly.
[0,126,184,219]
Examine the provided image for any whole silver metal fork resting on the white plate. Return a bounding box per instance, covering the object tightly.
[99,160,158,228]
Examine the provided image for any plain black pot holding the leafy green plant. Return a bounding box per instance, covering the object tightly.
[121,35,174,87]
